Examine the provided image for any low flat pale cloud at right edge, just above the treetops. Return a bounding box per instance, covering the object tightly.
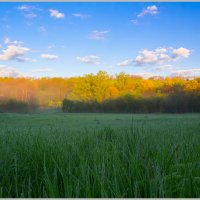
[171,68,200,77]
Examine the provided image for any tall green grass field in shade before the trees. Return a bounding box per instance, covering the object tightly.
[0,112,200,198]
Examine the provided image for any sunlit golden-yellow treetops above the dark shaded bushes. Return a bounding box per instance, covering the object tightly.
[0,71,200,112]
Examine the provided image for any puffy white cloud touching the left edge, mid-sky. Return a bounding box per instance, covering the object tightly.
[0,45,30,61]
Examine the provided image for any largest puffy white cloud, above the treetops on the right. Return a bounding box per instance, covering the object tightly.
[118,47,191,66]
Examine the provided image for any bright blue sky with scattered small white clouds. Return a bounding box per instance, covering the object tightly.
[0,2,200,77]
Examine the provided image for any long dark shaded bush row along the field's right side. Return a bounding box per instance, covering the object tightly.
[62,92,200,113]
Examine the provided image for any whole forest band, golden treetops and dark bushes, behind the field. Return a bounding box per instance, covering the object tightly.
[0,71,200,113]
